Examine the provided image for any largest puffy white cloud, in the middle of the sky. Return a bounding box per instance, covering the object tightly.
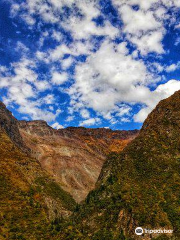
[69,41,149,115]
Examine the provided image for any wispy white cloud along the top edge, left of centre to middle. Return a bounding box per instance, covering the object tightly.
[11,0,118,40]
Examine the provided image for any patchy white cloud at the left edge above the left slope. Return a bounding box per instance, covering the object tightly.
[0,57,59,122]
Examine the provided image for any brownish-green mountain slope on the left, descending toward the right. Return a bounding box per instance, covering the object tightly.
[0,103,76,240]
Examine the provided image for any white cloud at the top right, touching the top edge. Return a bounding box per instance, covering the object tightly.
[113,0,168,55]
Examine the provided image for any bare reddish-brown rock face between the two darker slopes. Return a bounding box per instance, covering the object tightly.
[19,121,138,202]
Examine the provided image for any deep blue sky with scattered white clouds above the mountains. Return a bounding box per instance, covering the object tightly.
[0,0,180,130]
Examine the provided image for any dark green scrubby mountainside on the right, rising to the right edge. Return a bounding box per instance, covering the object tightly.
[62,91,180,240]
